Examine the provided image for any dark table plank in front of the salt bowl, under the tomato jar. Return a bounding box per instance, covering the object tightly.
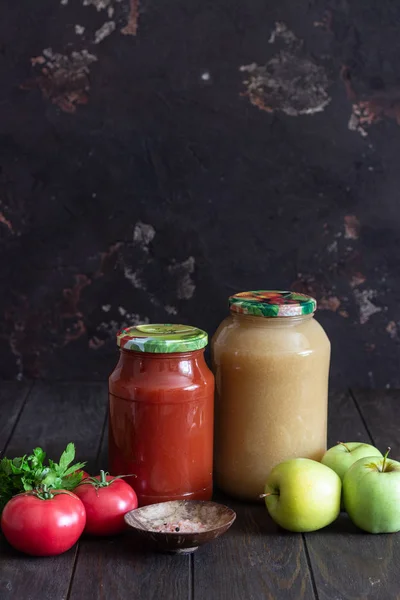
[69,422,190,600]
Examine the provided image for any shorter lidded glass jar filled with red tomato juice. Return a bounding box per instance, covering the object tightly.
[109,325,214,506]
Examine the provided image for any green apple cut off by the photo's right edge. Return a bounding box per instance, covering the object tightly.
[343,452,400,533]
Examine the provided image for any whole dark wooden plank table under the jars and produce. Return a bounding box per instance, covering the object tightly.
[0,383,400,600]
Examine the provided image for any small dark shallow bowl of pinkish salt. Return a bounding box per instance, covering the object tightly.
[125,500,236,554]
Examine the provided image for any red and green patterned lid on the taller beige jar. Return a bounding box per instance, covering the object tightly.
[229,290,317,317]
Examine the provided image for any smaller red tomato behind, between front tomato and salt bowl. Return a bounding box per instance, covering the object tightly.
[74,471,138,535]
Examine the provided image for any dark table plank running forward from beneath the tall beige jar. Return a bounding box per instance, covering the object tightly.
[193,493,315,600]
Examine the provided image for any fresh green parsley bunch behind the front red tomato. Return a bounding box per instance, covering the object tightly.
[0,443,86,513]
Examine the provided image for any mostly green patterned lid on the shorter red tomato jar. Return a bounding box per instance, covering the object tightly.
[117,324,208,354]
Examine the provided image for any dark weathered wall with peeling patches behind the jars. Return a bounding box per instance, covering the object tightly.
[0,0,400,387]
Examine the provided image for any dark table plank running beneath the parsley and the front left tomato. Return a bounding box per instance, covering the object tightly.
[0,383,107,600]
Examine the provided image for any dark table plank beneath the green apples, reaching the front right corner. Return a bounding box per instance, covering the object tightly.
[305,393,400,600]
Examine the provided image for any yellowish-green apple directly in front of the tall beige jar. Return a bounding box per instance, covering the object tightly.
[263,458,342,532]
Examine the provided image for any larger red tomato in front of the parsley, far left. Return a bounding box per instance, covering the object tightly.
[1,490,86,556]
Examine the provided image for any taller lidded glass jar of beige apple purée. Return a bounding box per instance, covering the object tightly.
[212,290,330,500]
